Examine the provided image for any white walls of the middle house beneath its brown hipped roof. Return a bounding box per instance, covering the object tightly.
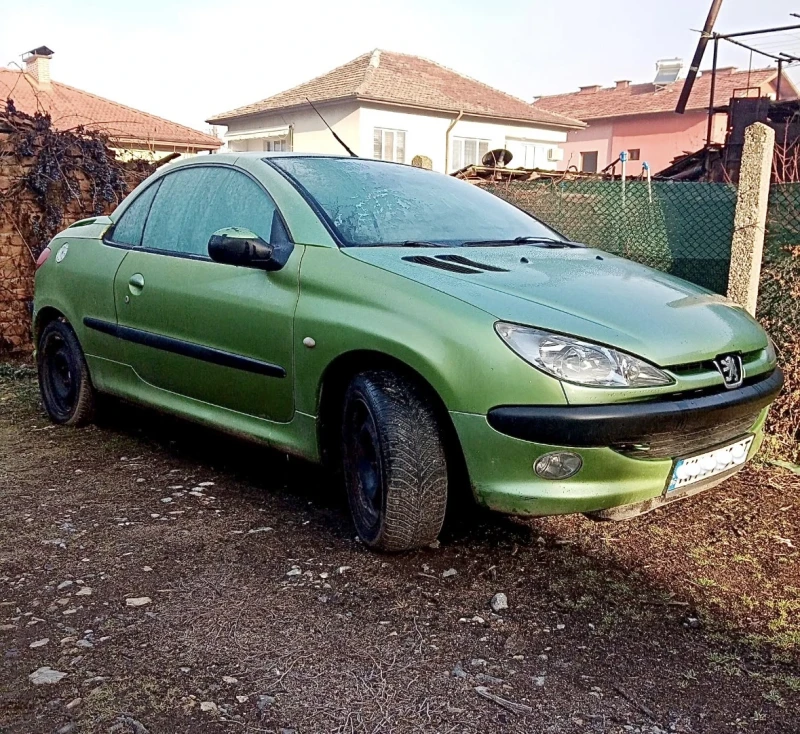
[219,102,567,171]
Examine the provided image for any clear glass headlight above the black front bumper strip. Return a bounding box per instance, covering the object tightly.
[495,321,673,387]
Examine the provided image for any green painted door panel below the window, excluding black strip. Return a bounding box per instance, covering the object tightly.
[114,247,303,423]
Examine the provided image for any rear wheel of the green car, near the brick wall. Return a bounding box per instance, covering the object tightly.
[36,319,96,427]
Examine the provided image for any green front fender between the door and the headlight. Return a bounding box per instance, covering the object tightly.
[295,247,566,415]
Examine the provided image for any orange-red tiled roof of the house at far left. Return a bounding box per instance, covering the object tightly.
[0,68,222,150]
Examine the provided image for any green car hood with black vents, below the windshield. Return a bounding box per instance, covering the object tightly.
[343,245,767,367]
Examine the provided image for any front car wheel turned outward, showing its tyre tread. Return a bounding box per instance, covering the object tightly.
[342,370,448,552]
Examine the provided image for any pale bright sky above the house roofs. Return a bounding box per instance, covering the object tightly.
[0,0,800,130]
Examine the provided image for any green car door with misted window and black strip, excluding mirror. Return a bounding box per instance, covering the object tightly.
[112,164,301,422]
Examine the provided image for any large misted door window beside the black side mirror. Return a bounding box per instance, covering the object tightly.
[142,166,278,257]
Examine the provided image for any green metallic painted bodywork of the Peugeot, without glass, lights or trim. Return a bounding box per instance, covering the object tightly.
[35,155,774,515]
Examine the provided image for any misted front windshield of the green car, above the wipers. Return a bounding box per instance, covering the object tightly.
[266,156,563,247]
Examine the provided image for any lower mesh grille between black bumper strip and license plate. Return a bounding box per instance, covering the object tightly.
[612,408,761,459]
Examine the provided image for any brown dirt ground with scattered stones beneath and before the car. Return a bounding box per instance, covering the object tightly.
[0,366,800,734]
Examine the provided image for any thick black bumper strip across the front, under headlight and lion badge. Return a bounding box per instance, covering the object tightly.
[486,367,783,448]
